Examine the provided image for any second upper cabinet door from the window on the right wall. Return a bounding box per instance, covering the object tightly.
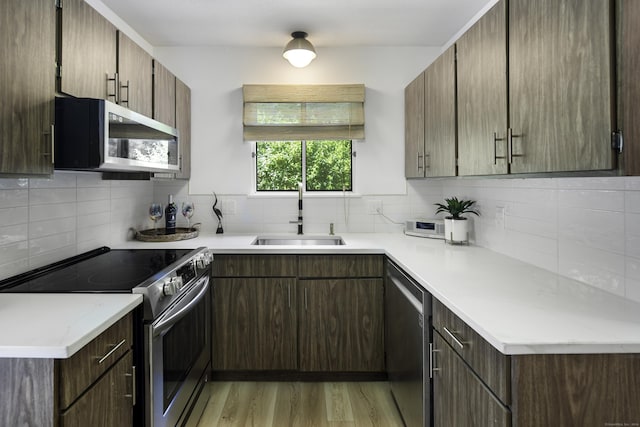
[424,46,456,177]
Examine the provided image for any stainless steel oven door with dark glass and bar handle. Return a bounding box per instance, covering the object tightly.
[145,274,211,427]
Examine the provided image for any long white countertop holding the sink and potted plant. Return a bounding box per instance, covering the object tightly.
[117,233,640,354]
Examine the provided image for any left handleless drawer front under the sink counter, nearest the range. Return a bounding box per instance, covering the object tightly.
[212,255,297,277]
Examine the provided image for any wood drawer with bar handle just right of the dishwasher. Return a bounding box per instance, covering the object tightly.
[433,299,511,405]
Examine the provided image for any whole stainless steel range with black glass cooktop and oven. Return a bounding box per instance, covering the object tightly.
[0,247,213,427]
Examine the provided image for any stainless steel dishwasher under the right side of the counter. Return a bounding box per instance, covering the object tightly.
[385,260,432,427]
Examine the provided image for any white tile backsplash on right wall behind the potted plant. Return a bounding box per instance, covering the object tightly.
[443,177,640,301]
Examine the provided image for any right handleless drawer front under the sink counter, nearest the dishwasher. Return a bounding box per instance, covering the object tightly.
[298,255,384,278]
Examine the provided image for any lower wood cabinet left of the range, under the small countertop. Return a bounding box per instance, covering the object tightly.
[0,314,134,427]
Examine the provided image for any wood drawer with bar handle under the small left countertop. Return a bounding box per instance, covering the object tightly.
[58,313,133,409]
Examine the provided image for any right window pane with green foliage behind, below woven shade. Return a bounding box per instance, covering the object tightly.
[306,140,351,191]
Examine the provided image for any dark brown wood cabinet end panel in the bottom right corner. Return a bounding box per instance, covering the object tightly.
[512,354,640,427]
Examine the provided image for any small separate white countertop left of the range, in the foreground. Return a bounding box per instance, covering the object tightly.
[0,293,142,359]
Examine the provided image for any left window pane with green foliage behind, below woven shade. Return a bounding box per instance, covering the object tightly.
[256,141,302,191]
